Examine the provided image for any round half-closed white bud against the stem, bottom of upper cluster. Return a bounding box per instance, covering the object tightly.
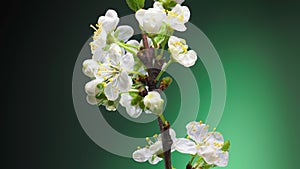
[144,91,164,115]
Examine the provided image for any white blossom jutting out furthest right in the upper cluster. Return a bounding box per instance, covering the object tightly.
[168,36,197,67]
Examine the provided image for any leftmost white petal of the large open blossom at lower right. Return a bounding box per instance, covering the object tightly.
[173,138,197,154]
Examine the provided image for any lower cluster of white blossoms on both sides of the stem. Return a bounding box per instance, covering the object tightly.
[132,121,229,168]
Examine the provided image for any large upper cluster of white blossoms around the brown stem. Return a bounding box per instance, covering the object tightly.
[83,1,197,118]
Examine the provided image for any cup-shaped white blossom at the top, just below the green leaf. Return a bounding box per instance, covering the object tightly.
[135,8,166,34]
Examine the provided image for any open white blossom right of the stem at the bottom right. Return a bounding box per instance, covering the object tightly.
[175,122,228,167]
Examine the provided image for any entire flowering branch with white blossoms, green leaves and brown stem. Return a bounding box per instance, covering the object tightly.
[82,0,229,169]
